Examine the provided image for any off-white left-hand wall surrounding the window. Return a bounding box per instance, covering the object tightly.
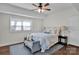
[0,14,42,46]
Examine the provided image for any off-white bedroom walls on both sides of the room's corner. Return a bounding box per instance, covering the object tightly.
[0,4,79,46]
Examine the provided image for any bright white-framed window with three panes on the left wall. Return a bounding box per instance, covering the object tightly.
[10,20,31,31]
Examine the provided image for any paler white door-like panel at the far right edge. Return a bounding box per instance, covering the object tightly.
[69,15,79,46]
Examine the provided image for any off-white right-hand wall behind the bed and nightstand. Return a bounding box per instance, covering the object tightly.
[43,8,79,46]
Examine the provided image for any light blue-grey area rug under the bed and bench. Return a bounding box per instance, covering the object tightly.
[10,44,63,55]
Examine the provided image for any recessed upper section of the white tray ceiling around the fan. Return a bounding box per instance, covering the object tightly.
[10,3,72,15]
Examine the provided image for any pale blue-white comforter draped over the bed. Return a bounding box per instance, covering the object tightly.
[24,33,57,52]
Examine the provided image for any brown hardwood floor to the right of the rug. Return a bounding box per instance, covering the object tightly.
[51,45,79,55]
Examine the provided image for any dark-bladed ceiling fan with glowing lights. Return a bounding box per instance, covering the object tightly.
[32,3,51,13]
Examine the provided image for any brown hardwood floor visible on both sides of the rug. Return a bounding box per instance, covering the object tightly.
[0,45,79,55]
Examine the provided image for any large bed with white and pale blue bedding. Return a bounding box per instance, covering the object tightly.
[24,26,58,52]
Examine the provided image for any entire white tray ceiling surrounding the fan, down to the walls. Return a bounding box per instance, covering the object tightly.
[0,3,79,18]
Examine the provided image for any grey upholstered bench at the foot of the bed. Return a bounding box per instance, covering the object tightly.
[24,38,41,53]
